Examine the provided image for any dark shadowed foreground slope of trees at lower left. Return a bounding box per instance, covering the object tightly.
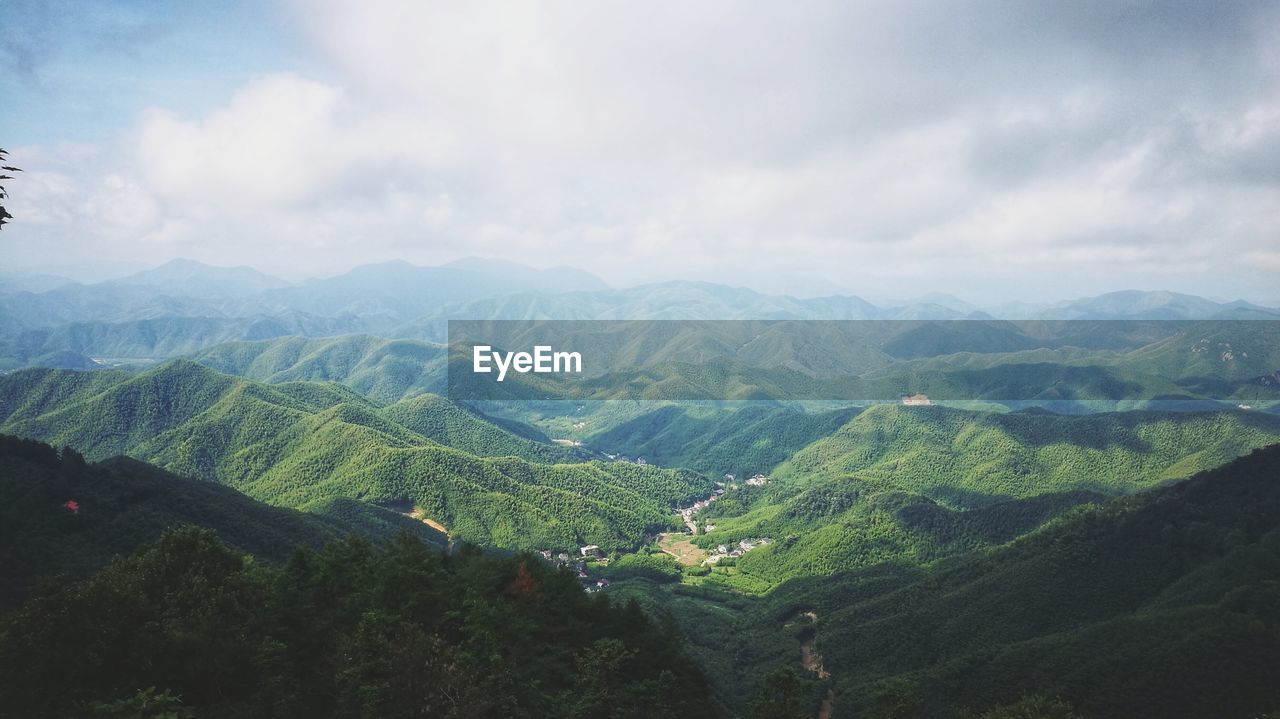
[0,436,716,719]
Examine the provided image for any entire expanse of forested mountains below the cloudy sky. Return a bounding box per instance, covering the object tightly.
[0,254,1280,719]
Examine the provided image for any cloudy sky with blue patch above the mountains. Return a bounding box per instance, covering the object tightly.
[0,0,1280,306]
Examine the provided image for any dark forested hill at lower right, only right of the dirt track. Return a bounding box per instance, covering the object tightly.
[767,446,1280,718]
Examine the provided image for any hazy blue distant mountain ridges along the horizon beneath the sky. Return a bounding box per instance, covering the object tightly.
[0,257,1280,371]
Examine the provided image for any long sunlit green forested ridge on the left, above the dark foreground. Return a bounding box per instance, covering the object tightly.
[0,361,710,549]
